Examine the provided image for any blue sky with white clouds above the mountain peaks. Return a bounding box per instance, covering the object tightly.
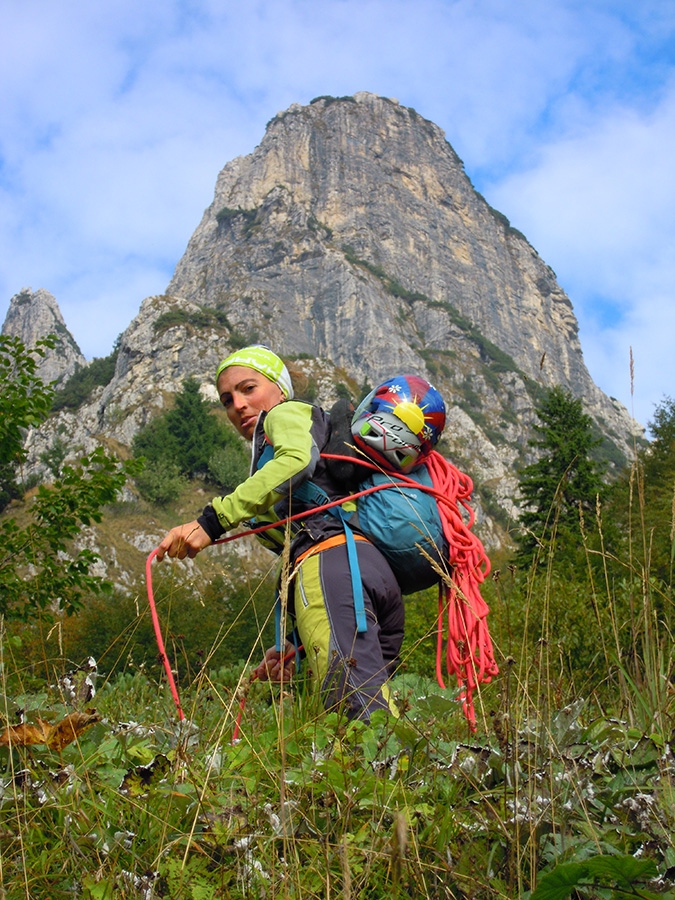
[0,0,675,424]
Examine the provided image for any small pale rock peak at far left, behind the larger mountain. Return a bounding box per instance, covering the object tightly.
[2,288,87,387]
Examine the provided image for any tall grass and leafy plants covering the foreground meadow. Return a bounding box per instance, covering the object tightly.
[0,479,675,900]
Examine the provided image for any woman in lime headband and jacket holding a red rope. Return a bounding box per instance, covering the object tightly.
[157,345,404,720]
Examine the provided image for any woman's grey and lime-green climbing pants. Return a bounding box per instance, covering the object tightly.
[293,541,405,720]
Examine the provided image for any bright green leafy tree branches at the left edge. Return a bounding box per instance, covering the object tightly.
[0,335,137,618]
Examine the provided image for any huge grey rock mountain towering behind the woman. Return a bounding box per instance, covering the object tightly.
[2,93,640,545]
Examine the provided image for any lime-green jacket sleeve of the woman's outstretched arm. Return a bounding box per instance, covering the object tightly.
[204,400,320,531]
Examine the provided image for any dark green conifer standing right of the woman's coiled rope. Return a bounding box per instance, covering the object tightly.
[519,387,604,562]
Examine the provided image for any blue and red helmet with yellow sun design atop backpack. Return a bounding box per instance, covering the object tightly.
[352,375,445,472]
